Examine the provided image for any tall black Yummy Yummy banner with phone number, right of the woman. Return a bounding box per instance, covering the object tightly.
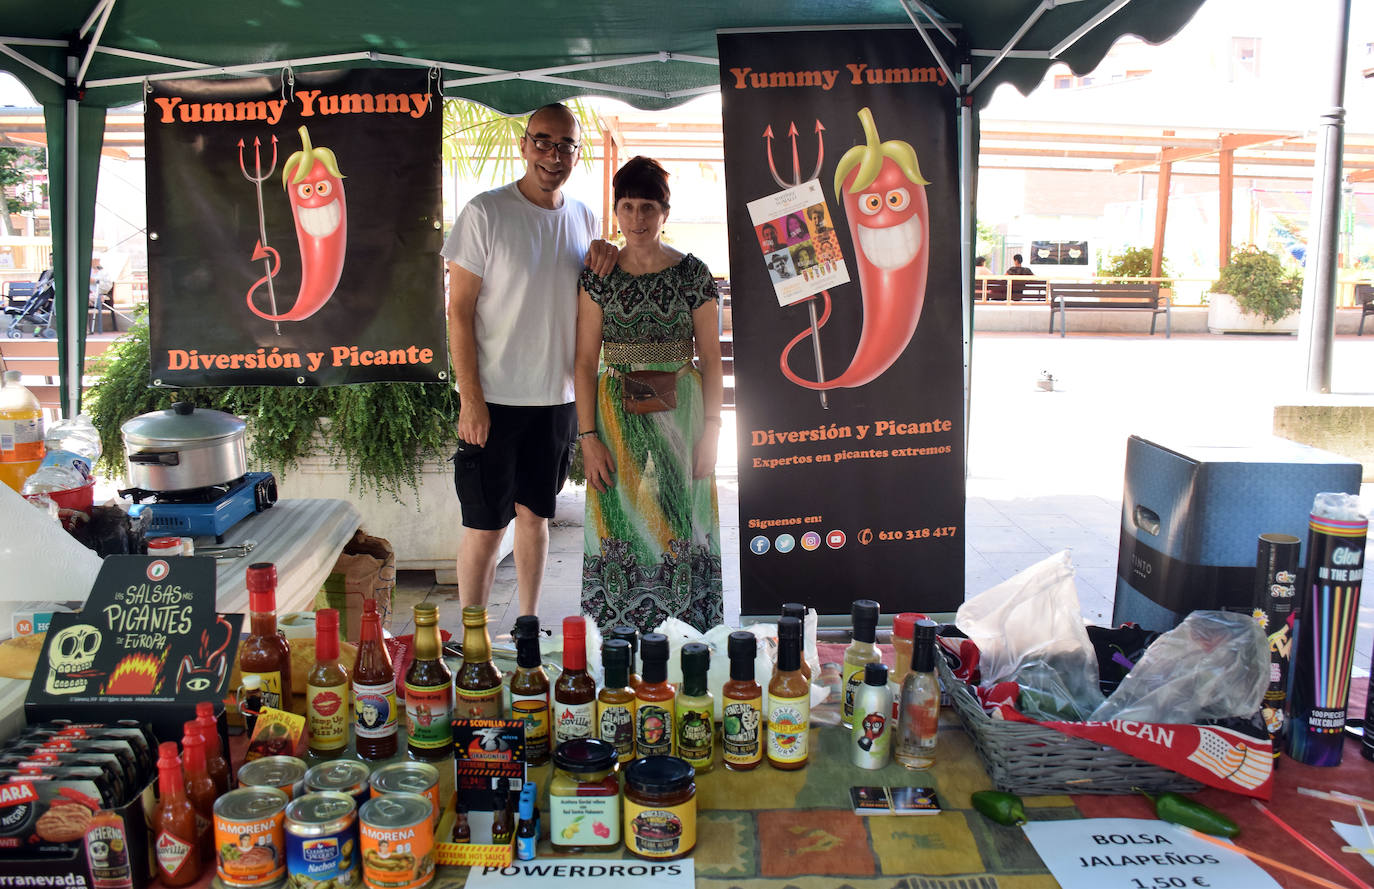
[719,27,965,614]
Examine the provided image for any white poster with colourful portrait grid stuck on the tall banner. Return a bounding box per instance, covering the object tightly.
[749,179,849,305]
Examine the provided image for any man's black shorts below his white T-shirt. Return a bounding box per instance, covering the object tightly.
[453,403,577,530]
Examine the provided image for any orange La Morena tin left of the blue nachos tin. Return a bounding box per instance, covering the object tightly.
[214,787,287,889]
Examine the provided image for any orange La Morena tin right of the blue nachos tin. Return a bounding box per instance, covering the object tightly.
[359,793,434,889]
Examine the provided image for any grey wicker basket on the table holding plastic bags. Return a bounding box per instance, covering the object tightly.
[936,658,1202,796]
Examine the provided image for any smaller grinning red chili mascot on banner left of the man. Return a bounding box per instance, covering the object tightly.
[247,126,348,322]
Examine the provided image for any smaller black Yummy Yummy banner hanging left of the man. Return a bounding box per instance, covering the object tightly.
[144,69,448,386]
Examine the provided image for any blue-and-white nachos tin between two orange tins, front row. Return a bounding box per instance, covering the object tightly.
[286,790,359,889]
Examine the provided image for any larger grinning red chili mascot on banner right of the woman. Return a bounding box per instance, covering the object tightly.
[780,109,930,389]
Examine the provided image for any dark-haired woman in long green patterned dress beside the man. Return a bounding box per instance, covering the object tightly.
[574,157,723,631]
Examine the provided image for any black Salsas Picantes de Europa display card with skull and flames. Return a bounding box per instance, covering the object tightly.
[27,555,243,705]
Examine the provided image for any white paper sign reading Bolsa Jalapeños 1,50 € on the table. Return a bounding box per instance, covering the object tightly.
[1021,818,1278,889]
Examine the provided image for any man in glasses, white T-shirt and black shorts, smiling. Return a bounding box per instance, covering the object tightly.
[442,104,616,614]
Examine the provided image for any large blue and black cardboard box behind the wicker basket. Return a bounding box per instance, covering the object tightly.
[1112,436,1362,631]
